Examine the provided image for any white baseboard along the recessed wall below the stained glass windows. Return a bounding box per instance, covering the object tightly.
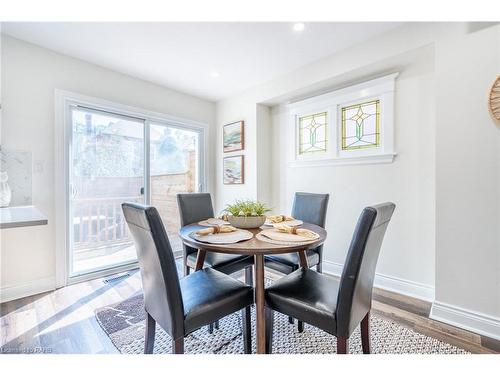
[323,260,434,302]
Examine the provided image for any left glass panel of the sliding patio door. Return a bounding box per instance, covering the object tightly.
[69,107,145,277]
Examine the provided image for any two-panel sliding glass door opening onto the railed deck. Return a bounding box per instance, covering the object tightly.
[67,105,203,279]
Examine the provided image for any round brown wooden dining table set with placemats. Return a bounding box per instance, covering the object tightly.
[180,223,326,354]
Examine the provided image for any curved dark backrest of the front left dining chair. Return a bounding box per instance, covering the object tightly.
[122,202,184,338]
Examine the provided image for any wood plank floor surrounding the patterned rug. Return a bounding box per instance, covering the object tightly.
[0,264,500,354]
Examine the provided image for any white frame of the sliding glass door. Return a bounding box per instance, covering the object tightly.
[54,89,209,288]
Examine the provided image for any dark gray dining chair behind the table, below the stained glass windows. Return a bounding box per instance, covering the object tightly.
[265,192,330,332]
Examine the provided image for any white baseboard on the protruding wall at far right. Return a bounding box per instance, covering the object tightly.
[430,301,500,340]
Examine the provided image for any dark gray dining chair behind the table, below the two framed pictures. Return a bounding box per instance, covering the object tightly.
[177,193,253,332]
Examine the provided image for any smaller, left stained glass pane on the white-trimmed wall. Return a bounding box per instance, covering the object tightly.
[299,112,328,155]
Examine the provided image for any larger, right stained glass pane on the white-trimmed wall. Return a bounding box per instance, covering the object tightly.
[342,100,380,151]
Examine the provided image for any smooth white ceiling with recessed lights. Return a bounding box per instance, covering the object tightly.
[2,22,402,101]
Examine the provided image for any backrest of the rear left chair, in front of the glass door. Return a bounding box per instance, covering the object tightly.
[177,193,214,226]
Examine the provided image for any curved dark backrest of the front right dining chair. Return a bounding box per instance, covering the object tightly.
[336,202,396,338]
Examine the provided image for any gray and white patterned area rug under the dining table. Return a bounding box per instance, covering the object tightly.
[96,294,468,354]
